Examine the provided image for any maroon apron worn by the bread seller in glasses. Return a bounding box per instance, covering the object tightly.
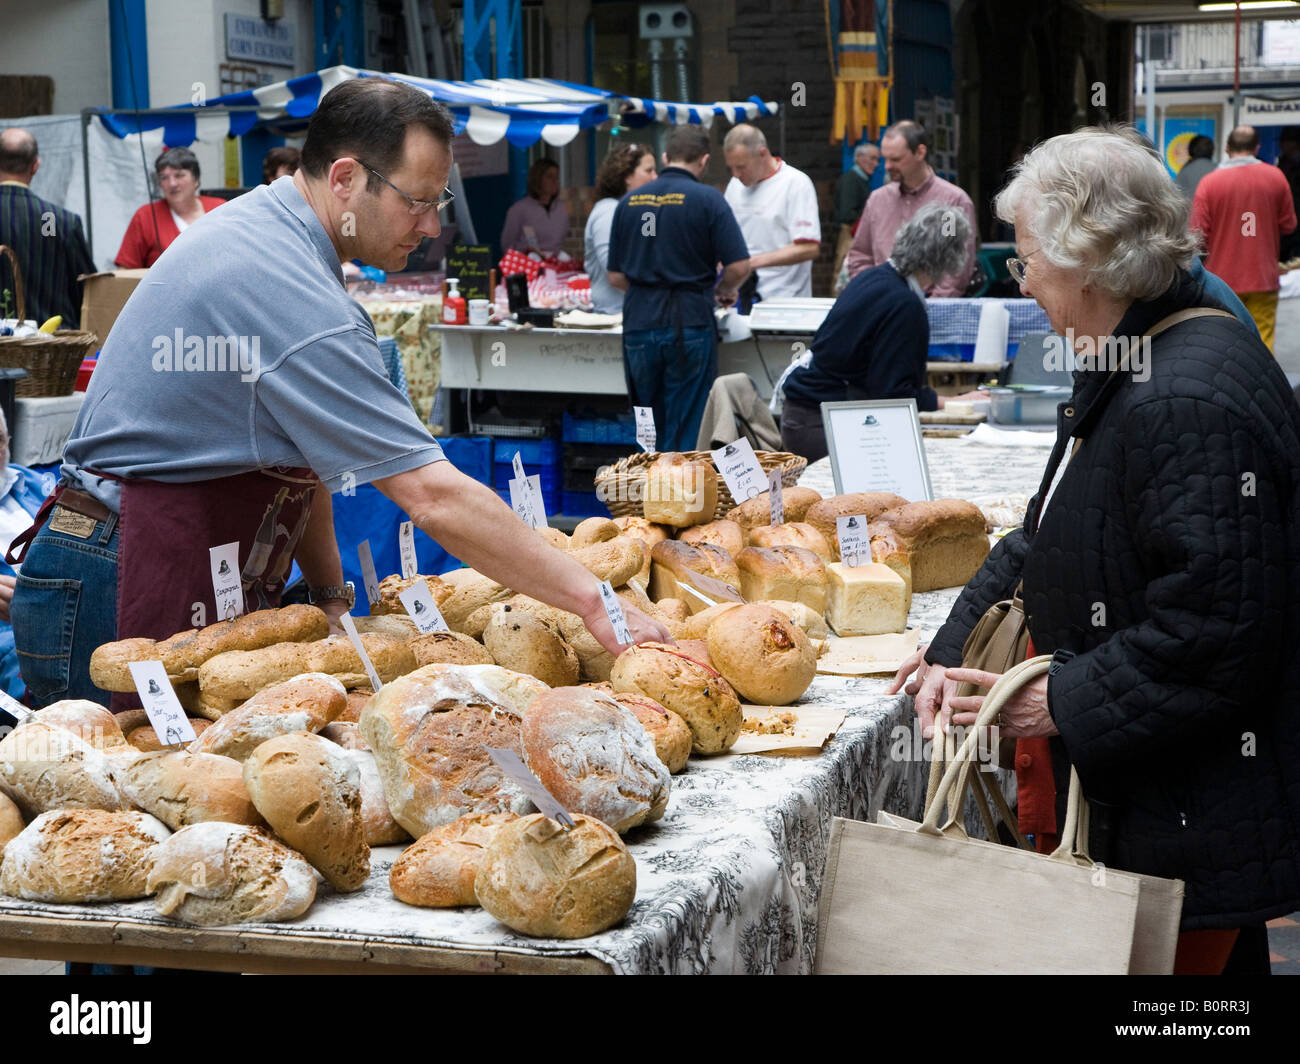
[112,468,320,712]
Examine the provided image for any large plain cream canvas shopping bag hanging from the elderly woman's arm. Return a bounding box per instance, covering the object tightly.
[815,656,1182,974]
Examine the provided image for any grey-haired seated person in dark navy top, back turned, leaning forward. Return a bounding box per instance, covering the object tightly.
[777,203,971,462]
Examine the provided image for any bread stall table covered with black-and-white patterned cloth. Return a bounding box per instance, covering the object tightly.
[0,440,1045,973]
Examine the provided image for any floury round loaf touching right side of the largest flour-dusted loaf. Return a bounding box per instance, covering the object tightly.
[520,687,670,835]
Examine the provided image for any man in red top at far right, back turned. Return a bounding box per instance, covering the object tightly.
[1190,126,1296,351]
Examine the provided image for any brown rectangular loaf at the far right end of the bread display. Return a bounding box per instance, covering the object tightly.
[871,498,989,592]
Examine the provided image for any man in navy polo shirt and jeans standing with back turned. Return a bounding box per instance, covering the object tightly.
[608,126,749,451]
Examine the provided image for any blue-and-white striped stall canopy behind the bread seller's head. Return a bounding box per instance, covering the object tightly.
[100,66,779,148]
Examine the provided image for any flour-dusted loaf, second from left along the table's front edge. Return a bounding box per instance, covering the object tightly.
[148,821,316,927]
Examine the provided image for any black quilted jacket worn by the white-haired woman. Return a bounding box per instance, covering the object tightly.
[927,277,1300,930]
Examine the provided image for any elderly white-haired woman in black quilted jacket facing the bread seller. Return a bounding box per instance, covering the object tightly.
[893,129,1300,973]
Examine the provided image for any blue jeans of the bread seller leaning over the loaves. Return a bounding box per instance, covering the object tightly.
[10,514,119,706]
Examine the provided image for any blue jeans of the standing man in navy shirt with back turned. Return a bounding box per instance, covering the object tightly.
[623,325,718,451]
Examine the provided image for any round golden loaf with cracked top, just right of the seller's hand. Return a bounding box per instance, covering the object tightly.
[709,604,816,705]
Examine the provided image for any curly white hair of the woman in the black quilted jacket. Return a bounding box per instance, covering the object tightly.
[993,126,1197,299]
